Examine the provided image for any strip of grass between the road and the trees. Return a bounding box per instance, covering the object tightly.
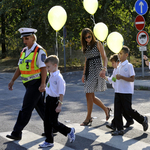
[0,53,141,72]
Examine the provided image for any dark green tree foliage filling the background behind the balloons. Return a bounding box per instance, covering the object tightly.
[0,0,150,61]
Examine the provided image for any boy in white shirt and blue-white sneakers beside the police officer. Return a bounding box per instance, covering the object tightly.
[39,55,75,148]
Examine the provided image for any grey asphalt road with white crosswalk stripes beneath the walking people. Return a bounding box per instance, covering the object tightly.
[0,73,150,150]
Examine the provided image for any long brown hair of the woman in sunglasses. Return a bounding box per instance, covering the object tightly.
[81,28,96,53]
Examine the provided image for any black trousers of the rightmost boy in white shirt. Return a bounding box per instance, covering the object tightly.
[114,93,144,130]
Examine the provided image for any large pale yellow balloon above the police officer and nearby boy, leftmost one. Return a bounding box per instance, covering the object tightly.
[48,6,67,31]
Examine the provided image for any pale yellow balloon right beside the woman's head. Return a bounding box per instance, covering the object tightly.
[93,22,108,42]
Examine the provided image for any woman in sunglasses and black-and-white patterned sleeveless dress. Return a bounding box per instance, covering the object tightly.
[80,28,111,126]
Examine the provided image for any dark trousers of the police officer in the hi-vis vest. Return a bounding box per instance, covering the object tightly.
[12,79,44,136]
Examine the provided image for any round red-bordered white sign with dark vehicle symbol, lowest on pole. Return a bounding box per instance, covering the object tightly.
[136,31,149,46]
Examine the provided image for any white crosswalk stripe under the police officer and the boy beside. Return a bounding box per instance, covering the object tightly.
[0,130,74,150]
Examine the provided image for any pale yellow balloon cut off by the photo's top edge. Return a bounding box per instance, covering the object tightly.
[83,0,98,15]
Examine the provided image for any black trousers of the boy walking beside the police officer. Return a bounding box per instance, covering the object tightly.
[44,96,71,143]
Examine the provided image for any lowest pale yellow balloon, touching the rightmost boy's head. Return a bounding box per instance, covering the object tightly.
[107,32,124,53]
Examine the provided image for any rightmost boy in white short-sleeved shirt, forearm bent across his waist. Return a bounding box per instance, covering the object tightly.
[112,46,148,136]
